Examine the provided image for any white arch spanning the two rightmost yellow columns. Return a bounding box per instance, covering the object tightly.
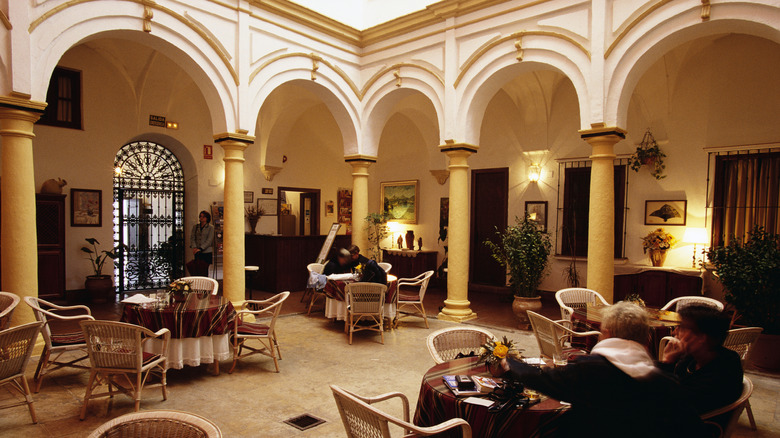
[448,37,590,144]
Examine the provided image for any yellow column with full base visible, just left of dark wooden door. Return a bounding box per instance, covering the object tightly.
[438,140,479,322]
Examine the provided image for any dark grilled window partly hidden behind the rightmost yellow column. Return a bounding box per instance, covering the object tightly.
[557,161,628,258]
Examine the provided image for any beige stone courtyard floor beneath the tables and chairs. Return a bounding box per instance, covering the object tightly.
[0,294,780,438]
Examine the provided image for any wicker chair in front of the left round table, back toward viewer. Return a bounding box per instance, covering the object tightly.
[79,321,171,420]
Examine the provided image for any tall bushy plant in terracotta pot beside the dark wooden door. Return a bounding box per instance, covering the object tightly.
[485,215,552,329]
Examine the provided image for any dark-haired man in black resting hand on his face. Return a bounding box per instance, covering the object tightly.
[659,305,742,414]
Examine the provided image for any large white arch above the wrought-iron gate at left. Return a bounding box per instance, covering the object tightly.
[31,2,238,132]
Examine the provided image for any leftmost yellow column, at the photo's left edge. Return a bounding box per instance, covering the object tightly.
[0,97,46,326]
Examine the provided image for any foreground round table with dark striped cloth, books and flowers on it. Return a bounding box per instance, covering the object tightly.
[414,357,568,438]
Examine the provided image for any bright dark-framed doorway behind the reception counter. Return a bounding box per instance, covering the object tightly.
[278,187,320,236]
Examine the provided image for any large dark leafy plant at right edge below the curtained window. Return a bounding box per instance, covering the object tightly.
[707,227,780,371]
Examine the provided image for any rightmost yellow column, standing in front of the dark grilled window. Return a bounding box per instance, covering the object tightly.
[580,123,626,303]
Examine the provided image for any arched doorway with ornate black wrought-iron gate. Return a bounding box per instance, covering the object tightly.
[114,141,184,294]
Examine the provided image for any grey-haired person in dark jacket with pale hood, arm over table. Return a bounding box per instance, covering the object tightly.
[505,302,708,437]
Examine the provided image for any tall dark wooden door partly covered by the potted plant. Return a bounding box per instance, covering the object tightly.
[469,167,509,286]
